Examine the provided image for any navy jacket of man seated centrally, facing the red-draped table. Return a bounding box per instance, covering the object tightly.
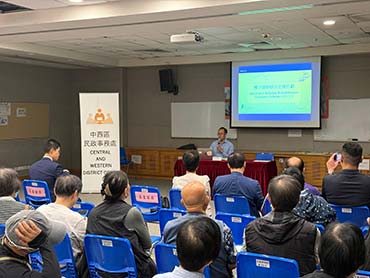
[212,172,263,217]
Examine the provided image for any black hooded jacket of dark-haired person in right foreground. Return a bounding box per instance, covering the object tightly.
[245,212,317,276]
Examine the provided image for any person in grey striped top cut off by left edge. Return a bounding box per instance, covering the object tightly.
[0,168,30,224]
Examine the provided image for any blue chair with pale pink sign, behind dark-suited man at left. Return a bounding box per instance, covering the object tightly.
[22,180,51,208]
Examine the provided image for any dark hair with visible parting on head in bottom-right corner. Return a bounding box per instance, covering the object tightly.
[319,223,365,278]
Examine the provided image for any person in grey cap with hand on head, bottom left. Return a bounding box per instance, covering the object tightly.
[0,210,66,278]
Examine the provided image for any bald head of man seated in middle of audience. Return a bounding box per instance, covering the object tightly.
[181,181,209,213]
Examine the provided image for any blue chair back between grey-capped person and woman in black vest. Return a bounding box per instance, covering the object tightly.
[54,234,78,278]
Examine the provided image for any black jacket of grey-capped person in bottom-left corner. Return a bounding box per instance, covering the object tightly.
[0,239,61,278]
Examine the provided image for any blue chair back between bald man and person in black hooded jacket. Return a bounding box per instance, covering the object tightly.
[216,213,256,245]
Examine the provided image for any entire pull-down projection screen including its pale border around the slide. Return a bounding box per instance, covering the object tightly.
[232,59,320,127]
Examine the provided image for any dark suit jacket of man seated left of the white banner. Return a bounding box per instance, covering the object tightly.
[29,157,65,202]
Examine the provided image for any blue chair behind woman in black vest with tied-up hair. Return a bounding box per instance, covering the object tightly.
[84,234,137,278]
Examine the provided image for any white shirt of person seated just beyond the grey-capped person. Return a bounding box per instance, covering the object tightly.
[37,203,87,258]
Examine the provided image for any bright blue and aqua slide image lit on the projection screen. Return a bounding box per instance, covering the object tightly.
[239,64,312,121]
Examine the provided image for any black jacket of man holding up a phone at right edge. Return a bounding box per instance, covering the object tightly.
[322,169,370,208]
